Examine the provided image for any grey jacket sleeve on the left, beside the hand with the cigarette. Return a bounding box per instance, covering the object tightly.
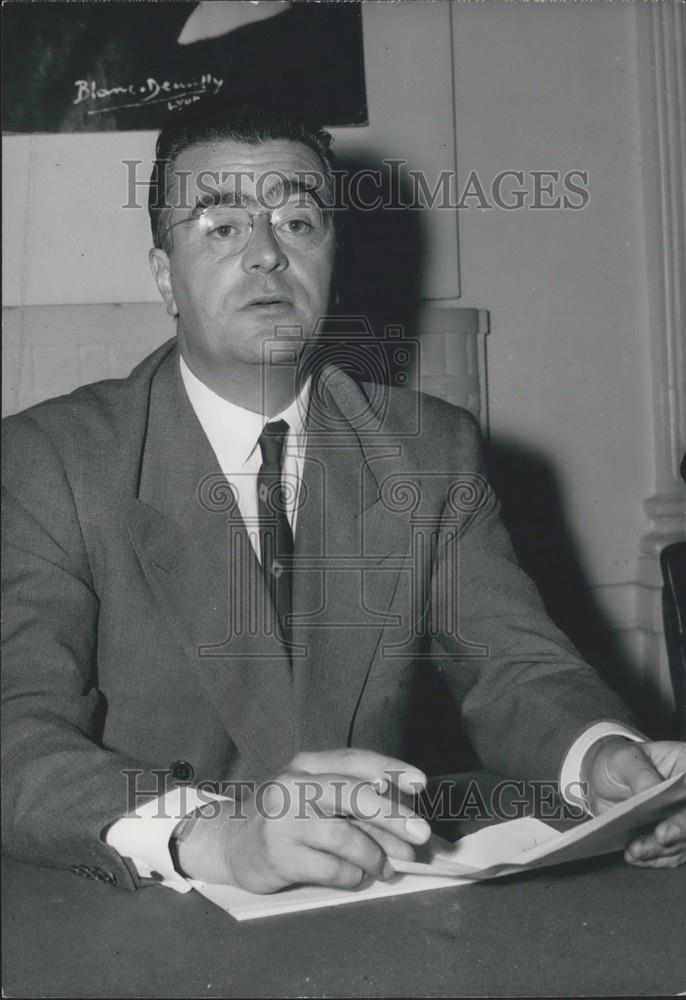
[2,415,177,889]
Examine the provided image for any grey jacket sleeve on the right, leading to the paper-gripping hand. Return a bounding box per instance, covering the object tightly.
[431,414,633,780]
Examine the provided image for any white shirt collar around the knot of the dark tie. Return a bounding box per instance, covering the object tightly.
[179,355,310,471]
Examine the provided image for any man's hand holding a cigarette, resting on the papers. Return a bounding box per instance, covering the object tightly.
[173,749,431,892]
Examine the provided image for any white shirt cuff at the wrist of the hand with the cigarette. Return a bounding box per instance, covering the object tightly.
[105,785,226,892]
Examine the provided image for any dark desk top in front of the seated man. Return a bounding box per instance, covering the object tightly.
[3,856,686,997]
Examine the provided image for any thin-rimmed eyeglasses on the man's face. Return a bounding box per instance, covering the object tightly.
[163,202,328,257]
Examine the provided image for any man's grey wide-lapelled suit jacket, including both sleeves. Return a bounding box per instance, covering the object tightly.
[3,342,627,888]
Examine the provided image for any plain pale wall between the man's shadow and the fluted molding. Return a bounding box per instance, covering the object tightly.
[453,2,686,720]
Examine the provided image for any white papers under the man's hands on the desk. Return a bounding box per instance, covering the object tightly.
[191,775,686,920]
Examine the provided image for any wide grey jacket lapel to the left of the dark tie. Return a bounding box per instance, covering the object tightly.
[127,351,295,780]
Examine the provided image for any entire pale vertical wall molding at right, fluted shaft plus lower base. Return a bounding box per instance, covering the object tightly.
[627,0,686,707]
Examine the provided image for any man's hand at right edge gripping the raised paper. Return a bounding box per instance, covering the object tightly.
[584,736,686,868]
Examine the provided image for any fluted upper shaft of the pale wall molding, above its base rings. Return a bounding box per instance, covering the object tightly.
[636,0,686,516]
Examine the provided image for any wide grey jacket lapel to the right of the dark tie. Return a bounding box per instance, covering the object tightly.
[293,371,407,750]
